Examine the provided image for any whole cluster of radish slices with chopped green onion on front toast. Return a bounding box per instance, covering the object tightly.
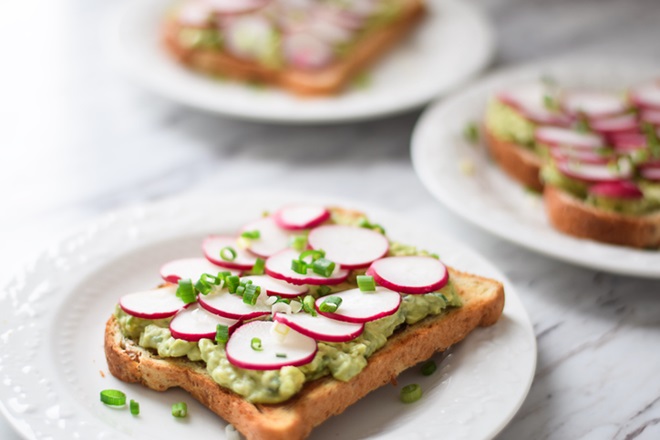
[119,205,448,370]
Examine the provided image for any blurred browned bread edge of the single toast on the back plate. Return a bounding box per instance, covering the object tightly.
[162,0,425,96]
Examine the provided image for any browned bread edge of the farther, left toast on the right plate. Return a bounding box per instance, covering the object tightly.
[484,127,543,192]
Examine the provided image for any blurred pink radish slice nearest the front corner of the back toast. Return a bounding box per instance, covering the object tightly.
[282,32,335,70]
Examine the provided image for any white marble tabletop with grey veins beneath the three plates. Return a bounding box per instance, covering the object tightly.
[0,0,660,440]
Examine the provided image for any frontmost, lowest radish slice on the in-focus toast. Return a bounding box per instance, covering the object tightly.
[225,321,317,370]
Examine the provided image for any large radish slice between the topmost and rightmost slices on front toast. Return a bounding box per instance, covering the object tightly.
[307,225,390,269]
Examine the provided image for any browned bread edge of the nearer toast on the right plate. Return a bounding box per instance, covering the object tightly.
[543,185,660,248]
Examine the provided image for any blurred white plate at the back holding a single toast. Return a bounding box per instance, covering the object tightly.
[110,0,494,123]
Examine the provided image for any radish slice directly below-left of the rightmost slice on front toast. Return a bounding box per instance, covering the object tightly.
[315,286,401,323]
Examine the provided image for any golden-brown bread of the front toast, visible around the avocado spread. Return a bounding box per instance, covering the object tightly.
[105,269,504,440]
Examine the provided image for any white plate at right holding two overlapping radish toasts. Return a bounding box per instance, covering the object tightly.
[412,59,660,278]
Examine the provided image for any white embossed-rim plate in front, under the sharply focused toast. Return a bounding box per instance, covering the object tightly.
[0,194,536,440]
